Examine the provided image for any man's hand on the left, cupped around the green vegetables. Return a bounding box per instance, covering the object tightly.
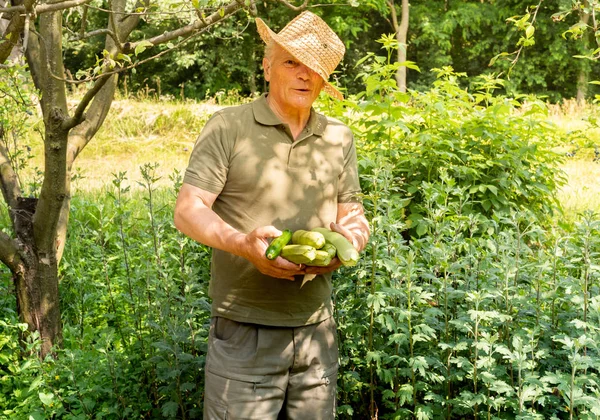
[242,226,306,281]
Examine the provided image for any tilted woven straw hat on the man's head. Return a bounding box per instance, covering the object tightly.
[256,12,346,99]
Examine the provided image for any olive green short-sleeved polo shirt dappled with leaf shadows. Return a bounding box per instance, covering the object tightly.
[183,95,360,327]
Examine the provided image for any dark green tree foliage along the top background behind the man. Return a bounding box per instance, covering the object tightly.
[56,0,600,102]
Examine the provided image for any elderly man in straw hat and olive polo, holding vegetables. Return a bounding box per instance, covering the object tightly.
[175,12,369,420]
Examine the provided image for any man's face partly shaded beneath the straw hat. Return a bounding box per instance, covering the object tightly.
[263,45,323,113]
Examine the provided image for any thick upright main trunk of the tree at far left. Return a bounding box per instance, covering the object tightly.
[6,7,68,358]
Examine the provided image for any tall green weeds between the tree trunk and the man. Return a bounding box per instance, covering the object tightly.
[0,164,210,419]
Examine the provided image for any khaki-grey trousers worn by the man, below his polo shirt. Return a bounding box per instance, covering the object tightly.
[204,317,338,420]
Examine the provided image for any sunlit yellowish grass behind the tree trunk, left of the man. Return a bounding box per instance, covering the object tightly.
[20,100,225,192]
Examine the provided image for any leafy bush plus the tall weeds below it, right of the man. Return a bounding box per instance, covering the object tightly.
[335,41,600,419]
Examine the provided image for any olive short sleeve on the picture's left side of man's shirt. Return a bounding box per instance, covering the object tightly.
[183,112,235,194]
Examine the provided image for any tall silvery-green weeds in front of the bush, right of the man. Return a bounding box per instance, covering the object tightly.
[336,180,600,419]
